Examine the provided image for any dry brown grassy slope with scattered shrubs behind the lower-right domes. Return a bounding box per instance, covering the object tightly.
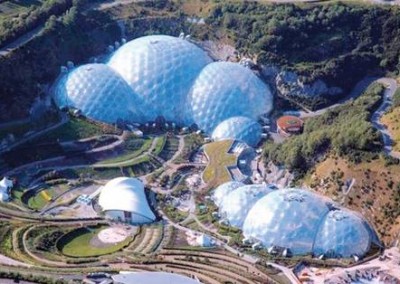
[300,157,400,244]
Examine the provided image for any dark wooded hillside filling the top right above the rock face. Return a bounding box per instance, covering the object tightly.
[206,1,400,108]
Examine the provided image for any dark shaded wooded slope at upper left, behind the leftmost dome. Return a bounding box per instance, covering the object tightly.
[0,0,120,121]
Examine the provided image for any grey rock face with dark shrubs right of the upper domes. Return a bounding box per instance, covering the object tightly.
[261,66,343,98]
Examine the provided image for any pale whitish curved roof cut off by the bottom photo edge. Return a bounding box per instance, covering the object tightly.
[112,272,200,284]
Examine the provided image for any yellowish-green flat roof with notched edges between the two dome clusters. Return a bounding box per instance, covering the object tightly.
[203,140,237,186]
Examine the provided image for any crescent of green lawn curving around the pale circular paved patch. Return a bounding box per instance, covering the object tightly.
[59,226,133,257]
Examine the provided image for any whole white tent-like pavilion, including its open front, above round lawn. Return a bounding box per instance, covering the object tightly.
[99,177,156,225]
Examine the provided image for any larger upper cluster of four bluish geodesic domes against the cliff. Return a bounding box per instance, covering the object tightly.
[54,35,272,145]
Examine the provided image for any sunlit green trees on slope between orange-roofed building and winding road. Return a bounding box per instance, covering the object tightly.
[264,84,384,173]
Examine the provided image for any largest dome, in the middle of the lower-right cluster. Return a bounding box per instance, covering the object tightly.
[243,189,329,255]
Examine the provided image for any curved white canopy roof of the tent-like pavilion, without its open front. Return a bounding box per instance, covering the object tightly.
[99,177,156,221]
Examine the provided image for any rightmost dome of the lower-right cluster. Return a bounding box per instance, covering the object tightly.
[313,210,374,258]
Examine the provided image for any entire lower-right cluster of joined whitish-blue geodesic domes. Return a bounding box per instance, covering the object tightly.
[213,182,380,258]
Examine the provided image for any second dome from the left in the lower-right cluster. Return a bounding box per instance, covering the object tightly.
[219,184,273,228]
